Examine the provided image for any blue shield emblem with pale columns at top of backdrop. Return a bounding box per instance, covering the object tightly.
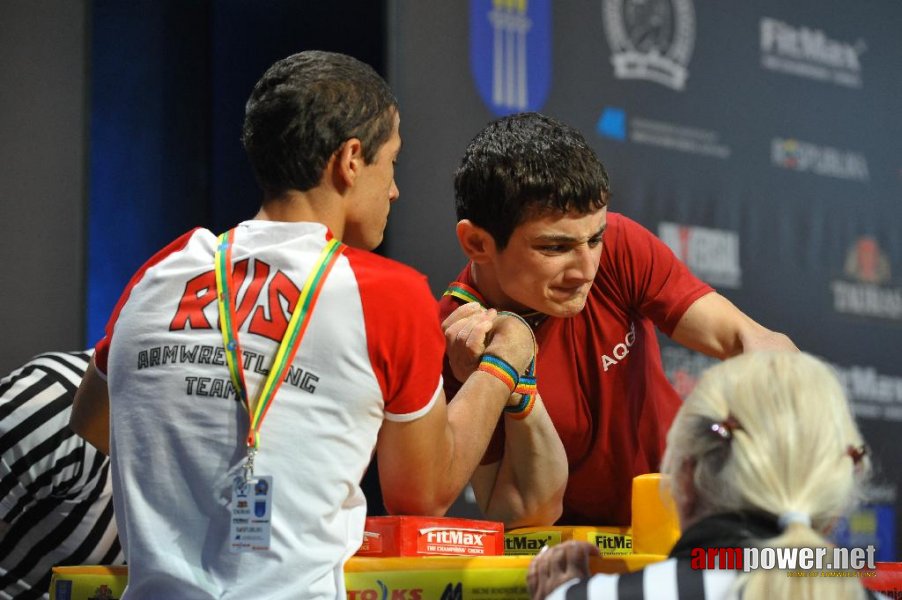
[470,0,551,117]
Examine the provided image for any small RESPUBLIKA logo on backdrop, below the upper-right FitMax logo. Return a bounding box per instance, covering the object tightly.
[770,138,871,182]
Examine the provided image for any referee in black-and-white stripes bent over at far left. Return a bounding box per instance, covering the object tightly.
[0,351,124,600]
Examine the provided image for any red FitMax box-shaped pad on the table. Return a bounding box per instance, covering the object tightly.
[357,516,504,556]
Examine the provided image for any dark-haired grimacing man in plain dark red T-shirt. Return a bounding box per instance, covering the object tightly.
[441,113,795,526]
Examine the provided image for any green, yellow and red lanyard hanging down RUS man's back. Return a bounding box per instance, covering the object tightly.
[214,229,346,482]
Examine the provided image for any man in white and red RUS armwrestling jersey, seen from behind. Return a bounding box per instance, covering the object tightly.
[72,51,564,600]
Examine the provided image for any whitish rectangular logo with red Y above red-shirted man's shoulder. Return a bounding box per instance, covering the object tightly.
[658,221,742,289]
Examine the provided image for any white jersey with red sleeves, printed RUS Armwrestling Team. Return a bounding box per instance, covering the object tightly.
[95,221,444,600]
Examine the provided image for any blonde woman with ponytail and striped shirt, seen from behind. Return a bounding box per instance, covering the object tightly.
[528,352,880,600]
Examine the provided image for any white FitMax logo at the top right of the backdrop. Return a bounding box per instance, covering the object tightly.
[760,17,867,88]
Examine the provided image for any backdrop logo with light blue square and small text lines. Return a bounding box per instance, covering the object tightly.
[595,106,732,159]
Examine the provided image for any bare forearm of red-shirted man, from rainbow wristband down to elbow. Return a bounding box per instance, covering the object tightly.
[474,397,567,529]
